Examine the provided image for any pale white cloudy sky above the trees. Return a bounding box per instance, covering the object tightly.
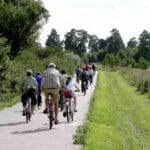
[39,0,150,46]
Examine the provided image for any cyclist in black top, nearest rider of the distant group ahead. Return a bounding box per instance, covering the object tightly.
[80,68,88,93]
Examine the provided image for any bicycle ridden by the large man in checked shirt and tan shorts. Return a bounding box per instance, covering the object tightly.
[48,93,54,130]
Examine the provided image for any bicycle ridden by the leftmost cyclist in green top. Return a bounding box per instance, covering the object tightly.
[25,98,32,123]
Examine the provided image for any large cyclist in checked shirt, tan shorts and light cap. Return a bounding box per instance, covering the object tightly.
[41,63,61,124]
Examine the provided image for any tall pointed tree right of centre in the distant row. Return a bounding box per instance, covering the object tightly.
[106,29,125,54]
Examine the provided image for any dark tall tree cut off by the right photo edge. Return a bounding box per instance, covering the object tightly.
[138,30,150,60]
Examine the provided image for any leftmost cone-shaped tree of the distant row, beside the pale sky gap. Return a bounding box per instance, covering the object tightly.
[46,29,62,48]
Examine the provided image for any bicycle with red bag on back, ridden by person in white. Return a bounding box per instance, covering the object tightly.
[64,90,74,123]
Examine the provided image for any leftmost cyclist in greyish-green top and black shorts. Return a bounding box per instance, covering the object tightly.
[21,70,38,115]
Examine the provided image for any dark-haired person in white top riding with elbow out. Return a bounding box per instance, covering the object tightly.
[66,76,80,112]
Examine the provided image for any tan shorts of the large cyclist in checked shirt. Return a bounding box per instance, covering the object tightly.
[43,89,60,103]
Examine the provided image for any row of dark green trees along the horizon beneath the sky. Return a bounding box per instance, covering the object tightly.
[46,28,150,68]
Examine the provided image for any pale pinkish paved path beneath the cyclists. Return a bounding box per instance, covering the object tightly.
[0,73,98,150]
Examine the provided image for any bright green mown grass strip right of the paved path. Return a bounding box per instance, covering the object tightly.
[85,71,150,150]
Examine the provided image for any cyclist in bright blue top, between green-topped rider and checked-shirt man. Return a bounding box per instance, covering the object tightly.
[34,72,42,107]
